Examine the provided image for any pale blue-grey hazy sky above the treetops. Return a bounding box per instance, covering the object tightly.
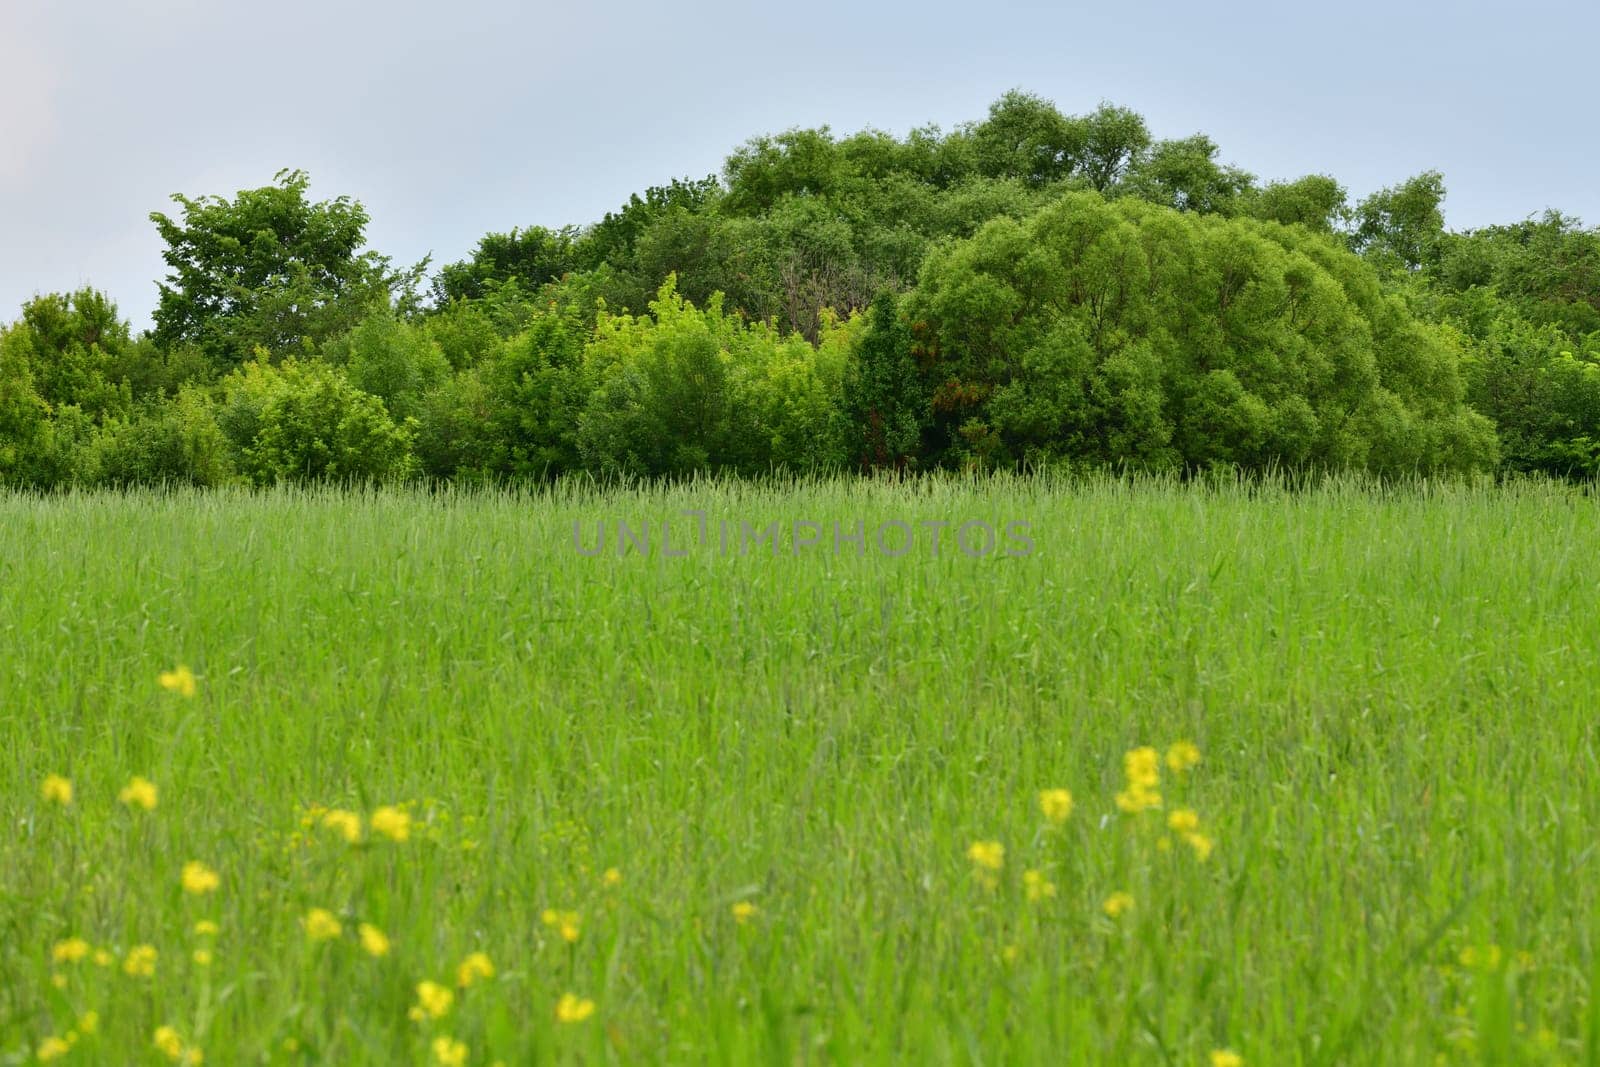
[0,0,1600,328]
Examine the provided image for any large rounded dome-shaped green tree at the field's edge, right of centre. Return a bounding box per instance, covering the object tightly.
[907,194,1493,472]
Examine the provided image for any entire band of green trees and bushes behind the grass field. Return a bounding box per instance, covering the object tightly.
[0,93,1600,488]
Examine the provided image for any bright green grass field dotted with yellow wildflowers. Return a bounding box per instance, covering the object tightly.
[0,480,1600,1065]
